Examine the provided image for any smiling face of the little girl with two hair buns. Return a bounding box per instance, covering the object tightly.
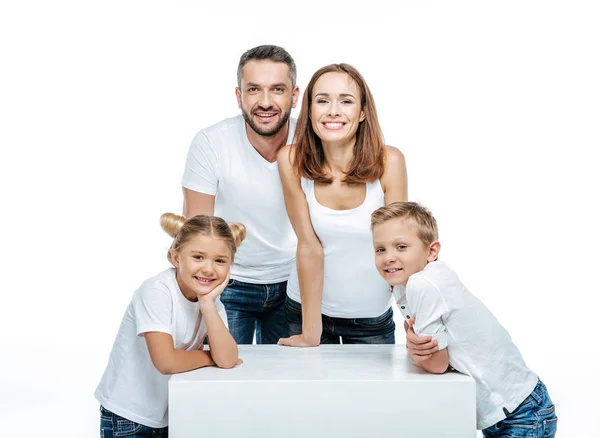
[171,234,232,301]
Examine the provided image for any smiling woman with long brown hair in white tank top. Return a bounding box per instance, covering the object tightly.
[277,64,407,347]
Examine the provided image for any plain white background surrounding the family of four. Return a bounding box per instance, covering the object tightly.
[0,0,600,438]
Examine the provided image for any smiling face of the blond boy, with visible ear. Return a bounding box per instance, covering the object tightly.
[373,218,440,286]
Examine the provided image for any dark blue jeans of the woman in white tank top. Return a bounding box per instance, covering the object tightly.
[285,297,396,344]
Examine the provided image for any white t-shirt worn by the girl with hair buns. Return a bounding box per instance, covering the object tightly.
[94,268,227,428]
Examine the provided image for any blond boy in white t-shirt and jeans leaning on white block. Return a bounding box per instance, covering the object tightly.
[371,202,557,438]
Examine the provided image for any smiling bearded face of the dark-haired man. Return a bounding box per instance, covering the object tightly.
[236,60,299,137]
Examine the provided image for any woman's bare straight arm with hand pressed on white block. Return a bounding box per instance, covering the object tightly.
[277,145,325,347]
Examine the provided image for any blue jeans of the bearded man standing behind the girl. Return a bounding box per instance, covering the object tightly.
[221,280,288,344]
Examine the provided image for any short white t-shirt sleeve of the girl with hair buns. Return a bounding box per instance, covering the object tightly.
[133,287,173,336]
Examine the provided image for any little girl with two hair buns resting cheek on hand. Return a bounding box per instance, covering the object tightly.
[95,213,246,437]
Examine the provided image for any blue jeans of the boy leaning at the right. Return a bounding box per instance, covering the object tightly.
[482,380,558,438]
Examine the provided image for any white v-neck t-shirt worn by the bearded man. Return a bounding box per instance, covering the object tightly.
[181,115,297,284]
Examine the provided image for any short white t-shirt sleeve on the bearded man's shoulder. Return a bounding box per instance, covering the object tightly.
[181,131,219,195]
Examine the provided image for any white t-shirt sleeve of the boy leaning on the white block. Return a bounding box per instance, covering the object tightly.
[406,277,448,350]
